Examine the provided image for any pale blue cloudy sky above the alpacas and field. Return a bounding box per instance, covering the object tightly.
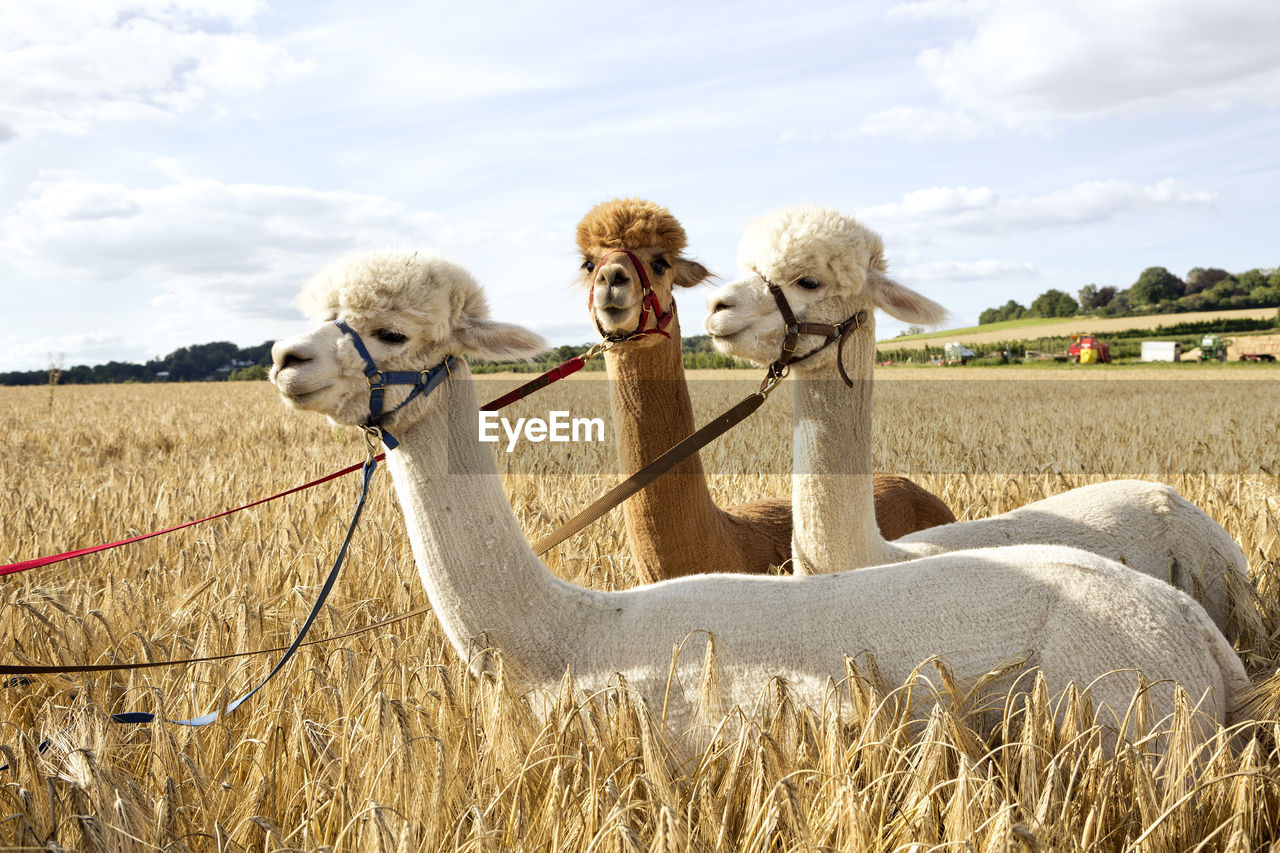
[0,0,1280,371]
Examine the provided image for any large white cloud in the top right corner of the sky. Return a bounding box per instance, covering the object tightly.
[906,0,1280,128]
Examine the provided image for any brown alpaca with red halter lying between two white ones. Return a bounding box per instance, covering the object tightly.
[577,199,955,583]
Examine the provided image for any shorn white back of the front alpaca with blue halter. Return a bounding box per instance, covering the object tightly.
[560,546,1248,734]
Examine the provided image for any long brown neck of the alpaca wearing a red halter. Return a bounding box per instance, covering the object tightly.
[605,312,739,583]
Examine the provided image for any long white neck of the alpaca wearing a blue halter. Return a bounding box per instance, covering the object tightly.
[387,366,600,681]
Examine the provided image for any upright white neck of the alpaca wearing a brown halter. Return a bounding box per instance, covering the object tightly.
[791,318,906,574]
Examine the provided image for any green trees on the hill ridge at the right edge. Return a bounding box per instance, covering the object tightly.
[978,266,1280,325]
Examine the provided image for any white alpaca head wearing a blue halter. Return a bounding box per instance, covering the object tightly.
[271,251,547,427]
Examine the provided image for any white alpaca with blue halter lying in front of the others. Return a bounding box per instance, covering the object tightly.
[271,252,1248,733]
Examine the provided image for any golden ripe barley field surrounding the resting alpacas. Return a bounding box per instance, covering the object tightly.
[0,368,1280,852]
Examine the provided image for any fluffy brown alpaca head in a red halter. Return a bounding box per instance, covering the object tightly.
[577,199,710,346]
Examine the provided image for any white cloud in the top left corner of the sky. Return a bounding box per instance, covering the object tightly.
[0,0,301,136]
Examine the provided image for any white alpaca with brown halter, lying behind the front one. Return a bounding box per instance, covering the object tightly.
[705,206,1249,637]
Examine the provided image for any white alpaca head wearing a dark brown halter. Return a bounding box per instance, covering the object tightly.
[705,206,946,371]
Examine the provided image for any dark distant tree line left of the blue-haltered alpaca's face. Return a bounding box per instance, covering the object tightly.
[0,341,274,386]
